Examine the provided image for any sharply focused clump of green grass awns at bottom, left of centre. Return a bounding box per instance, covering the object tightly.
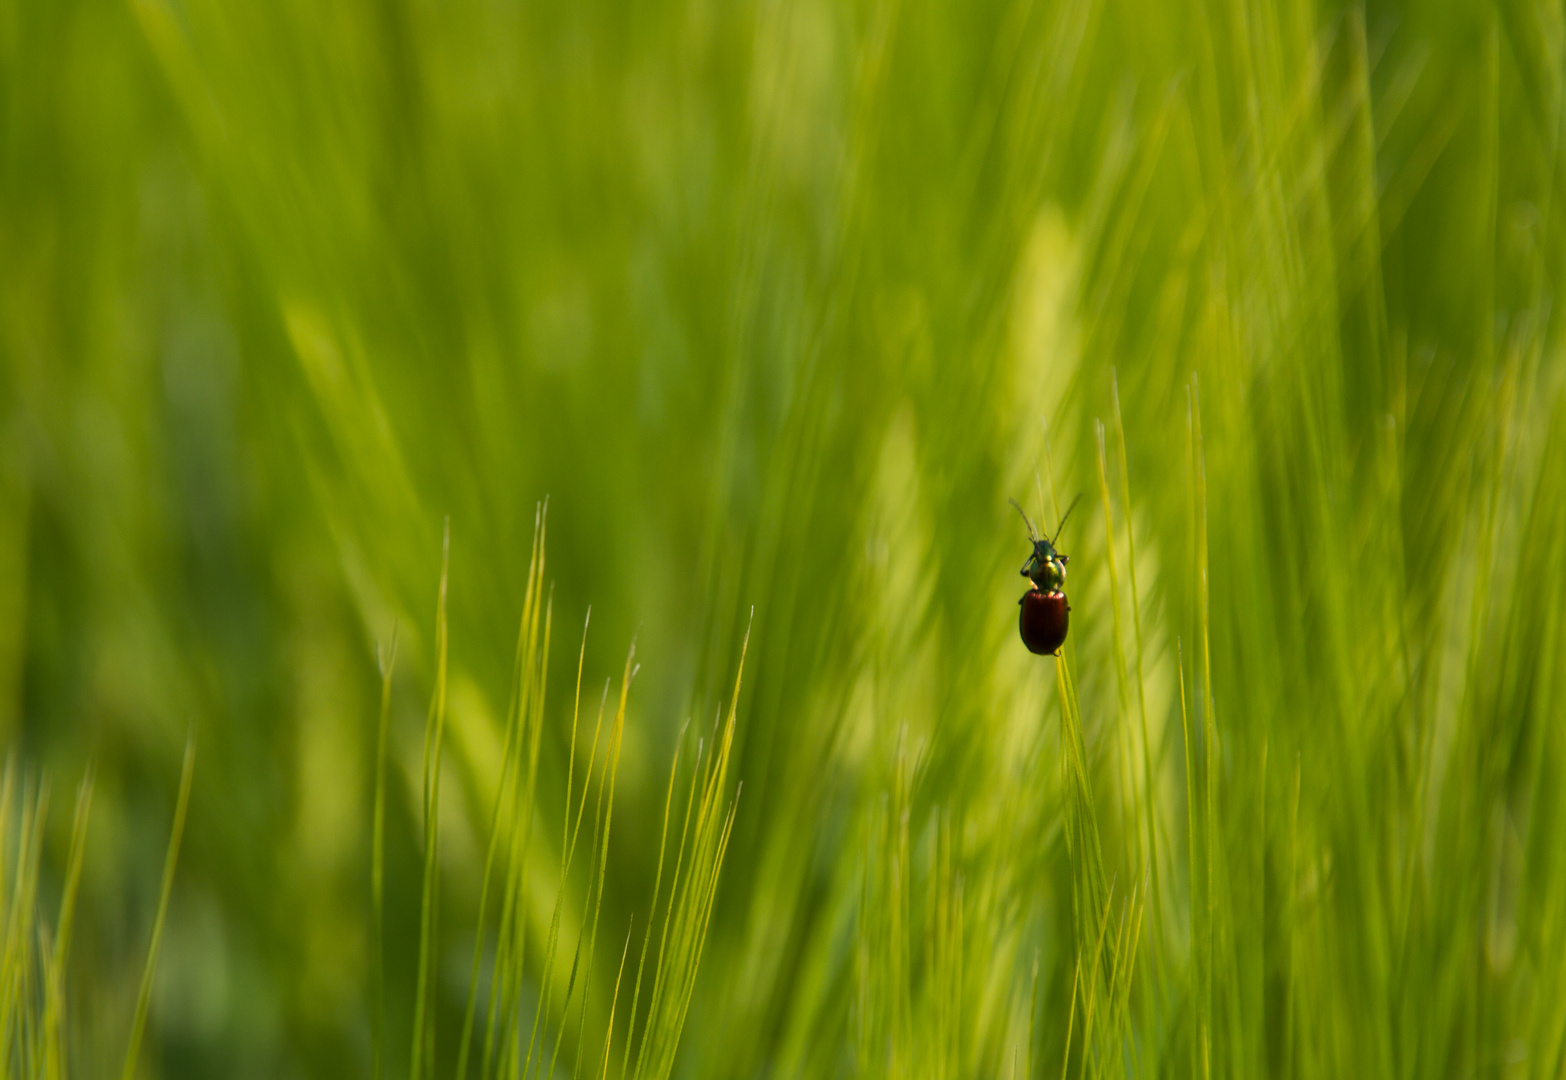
[371,502,744,1080]
